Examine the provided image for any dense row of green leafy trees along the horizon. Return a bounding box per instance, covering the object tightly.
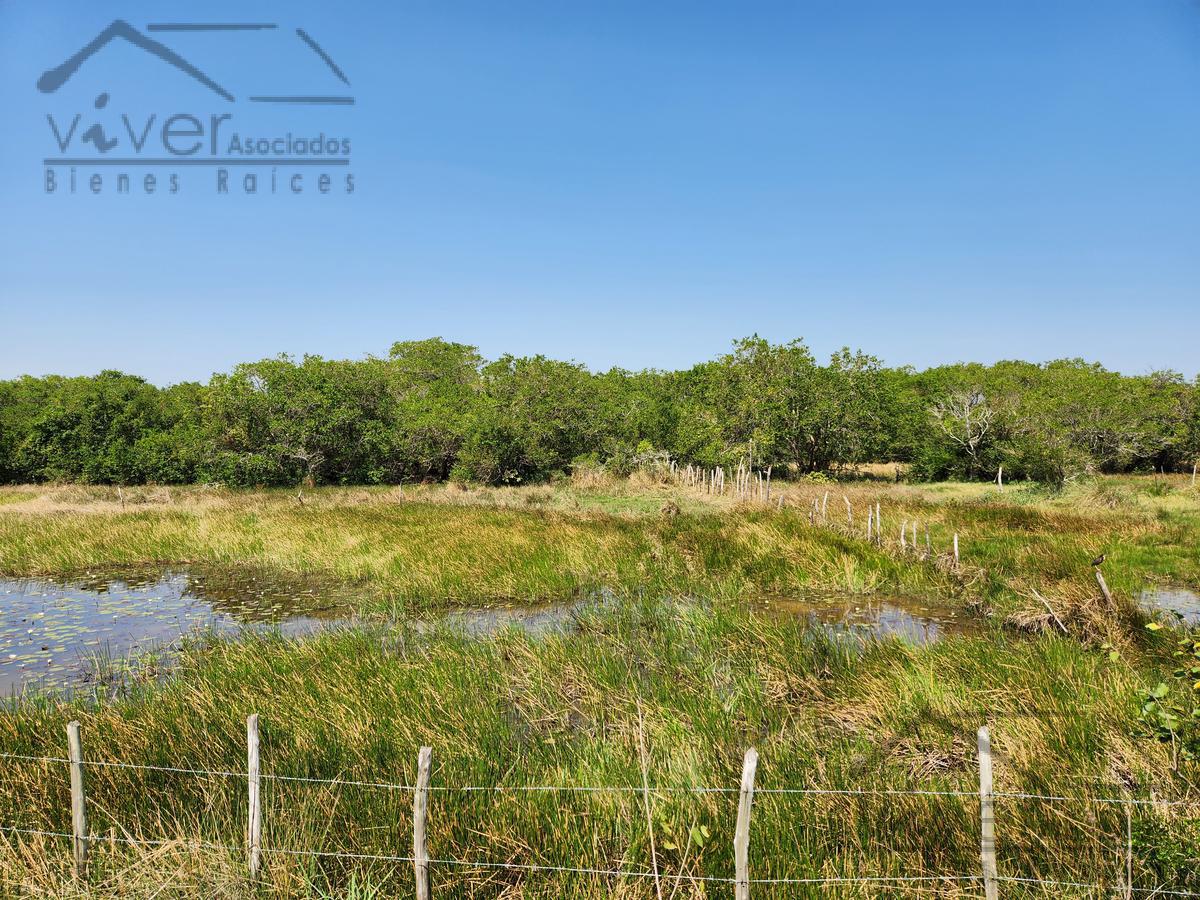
[0,336,1200,486]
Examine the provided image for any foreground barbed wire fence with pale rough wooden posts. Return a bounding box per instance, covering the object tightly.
[0,715,1200,900]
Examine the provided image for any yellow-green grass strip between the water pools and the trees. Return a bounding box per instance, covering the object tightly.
[0,478,1200,614]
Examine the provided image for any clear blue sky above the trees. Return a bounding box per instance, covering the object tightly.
[0,0,1200,383]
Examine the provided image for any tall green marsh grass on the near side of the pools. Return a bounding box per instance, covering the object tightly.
[0,600,1200,898]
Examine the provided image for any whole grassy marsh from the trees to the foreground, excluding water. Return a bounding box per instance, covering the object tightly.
[0,479,1200,900]
